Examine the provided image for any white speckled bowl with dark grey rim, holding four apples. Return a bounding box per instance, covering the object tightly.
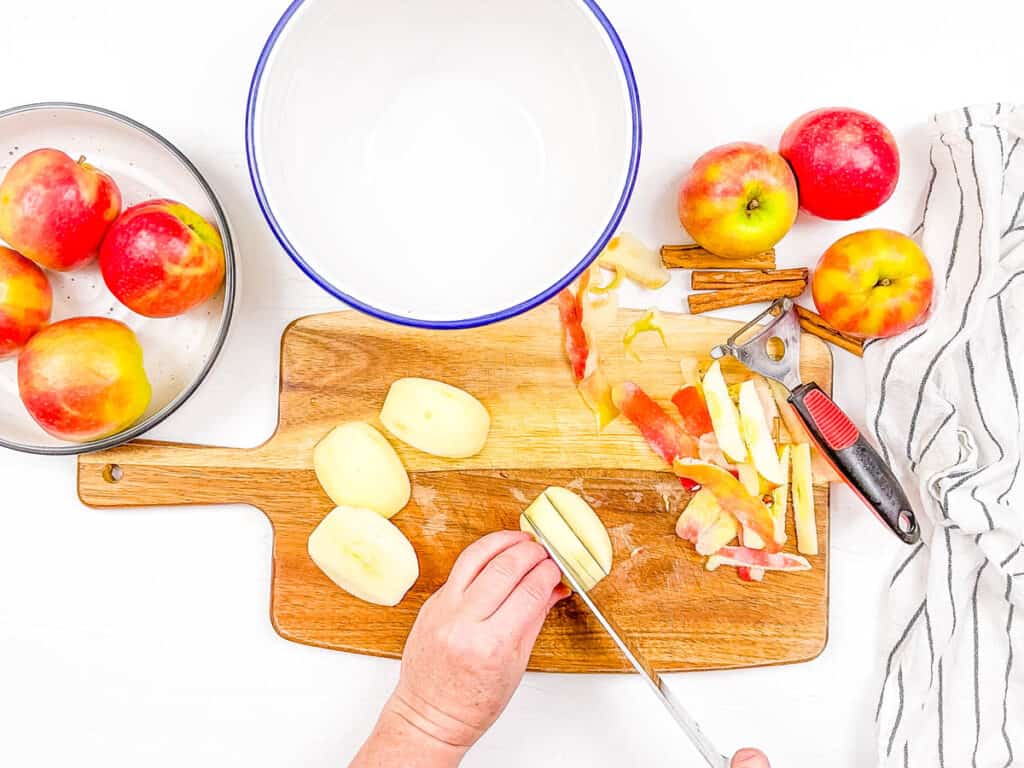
[0,103,236,455]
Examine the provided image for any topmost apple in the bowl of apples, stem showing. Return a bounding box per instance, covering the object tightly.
[0,150,121,271]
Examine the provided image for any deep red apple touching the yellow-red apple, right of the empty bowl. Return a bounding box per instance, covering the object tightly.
[778,106,899,219]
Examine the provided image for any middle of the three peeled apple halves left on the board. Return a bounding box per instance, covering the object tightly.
[313,421,411,517]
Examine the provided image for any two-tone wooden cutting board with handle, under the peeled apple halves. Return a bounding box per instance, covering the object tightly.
[78,304,831,672]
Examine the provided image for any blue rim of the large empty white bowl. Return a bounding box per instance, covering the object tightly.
[246,0,643,330]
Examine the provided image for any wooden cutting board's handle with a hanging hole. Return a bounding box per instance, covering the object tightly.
[78,440,258,507]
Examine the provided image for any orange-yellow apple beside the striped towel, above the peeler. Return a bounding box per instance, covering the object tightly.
[811,229,933,338]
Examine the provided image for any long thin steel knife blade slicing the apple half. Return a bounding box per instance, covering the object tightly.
[522,512,729,768]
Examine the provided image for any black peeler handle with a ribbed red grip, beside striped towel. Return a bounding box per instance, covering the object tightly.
[790,383,921,544]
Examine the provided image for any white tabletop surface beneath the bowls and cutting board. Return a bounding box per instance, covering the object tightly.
[0,0,1024,768]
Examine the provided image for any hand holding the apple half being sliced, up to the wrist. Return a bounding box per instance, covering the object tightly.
[386,530,570,751]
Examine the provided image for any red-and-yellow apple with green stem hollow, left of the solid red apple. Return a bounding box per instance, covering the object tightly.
[679,141,798,258]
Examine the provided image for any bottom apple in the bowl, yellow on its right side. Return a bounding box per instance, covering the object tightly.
[17,317,151,442]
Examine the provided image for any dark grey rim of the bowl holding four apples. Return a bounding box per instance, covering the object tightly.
[0,101,238,456]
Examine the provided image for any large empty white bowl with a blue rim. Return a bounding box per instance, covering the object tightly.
[246,0,640,328]
